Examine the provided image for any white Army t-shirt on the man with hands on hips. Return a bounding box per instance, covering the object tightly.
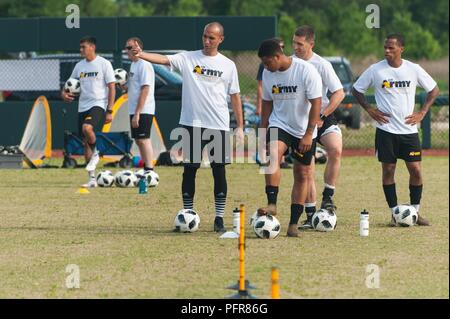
[353,59,436,134]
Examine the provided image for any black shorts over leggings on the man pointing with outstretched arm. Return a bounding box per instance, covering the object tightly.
[182,125,231,167]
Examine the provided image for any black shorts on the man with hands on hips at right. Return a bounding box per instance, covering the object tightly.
[375,128,422,163]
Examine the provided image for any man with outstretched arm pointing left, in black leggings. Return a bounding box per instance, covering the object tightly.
[133,22,243,233]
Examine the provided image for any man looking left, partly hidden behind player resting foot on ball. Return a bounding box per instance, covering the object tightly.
[292,25,345,230]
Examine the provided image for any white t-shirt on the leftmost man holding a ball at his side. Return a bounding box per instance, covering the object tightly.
[70,55,116,112]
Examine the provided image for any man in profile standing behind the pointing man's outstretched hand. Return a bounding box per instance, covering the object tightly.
[122,37,155,172]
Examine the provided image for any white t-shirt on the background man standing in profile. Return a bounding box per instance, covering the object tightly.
[128,59,155,115]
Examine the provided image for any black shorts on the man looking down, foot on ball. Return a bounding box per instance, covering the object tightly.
[266,127,317,165]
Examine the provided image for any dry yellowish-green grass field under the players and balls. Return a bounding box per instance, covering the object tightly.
[0,157,449,298]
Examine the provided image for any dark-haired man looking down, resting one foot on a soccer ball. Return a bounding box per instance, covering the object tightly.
[258,39,322,237]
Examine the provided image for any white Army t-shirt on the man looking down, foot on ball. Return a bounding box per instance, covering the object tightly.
[262,59,322,138]
